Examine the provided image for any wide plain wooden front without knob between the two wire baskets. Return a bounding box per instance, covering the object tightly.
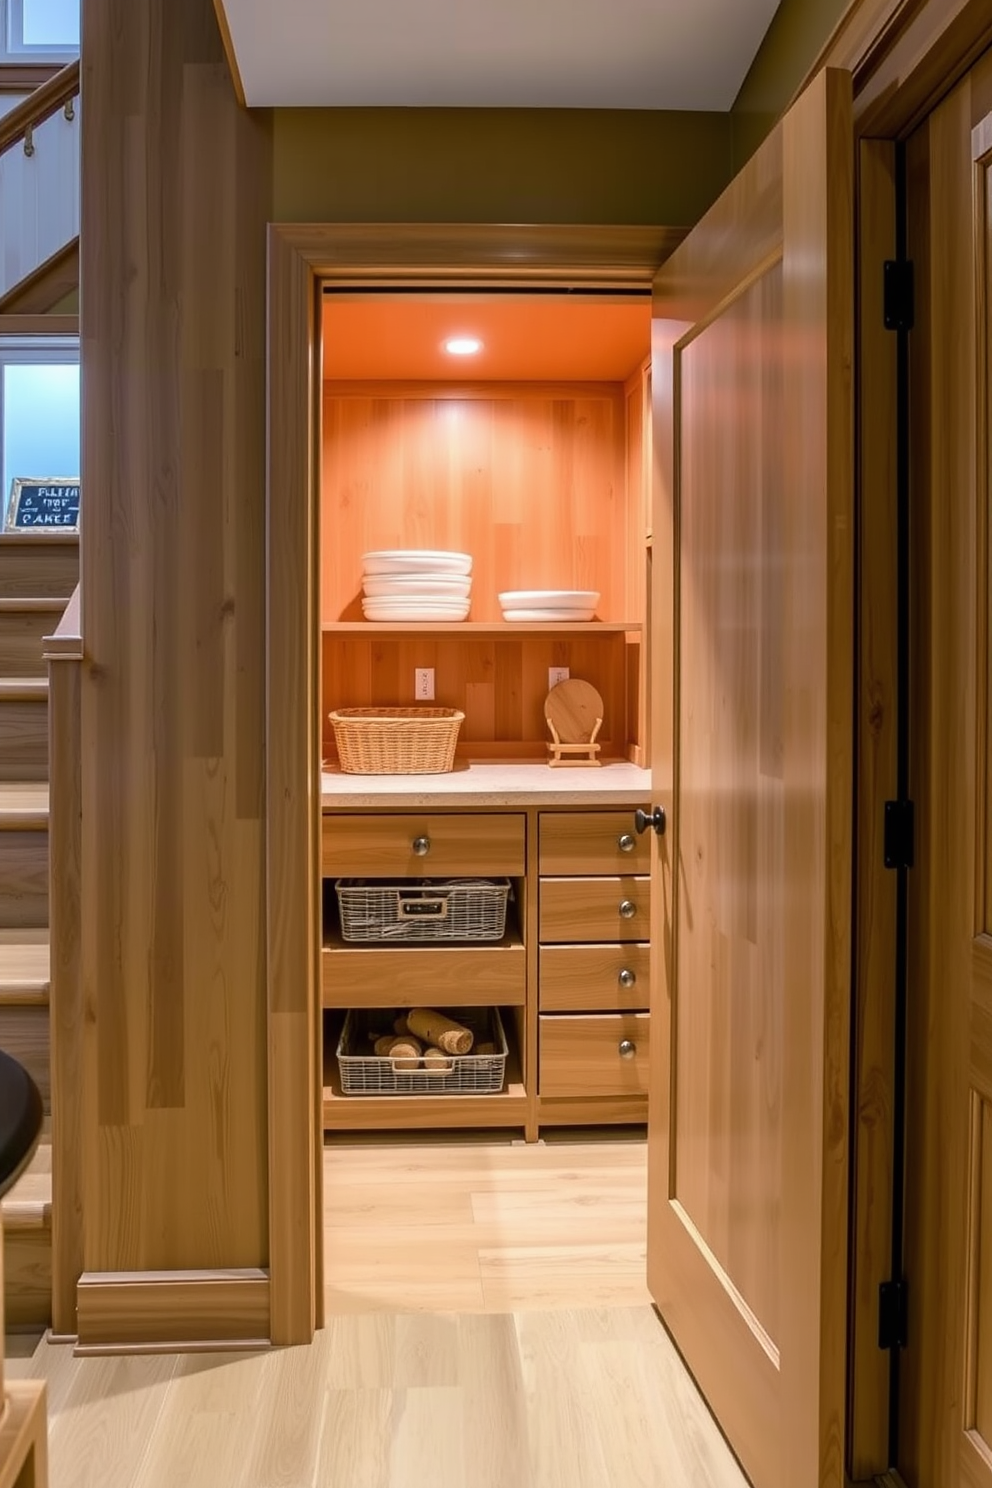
[321,945,526,1007]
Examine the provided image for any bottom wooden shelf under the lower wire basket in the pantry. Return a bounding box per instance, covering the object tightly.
[324,1019,528,1131]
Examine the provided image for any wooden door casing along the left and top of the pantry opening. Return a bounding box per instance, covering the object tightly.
[265,223,686,1344]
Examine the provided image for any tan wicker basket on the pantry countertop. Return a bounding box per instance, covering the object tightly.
[329,708,466,775]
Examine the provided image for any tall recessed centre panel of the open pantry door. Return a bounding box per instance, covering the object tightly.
[674,260,785,1342]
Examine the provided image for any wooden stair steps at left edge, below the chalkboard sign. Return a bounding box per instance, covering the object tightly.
[0,533,79,1329]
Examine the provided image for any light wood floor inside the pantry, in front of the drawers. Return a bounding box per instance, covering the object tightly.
[324,1134,650,1314]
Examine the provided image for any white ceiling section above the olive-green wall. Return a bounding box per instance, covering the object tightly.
[222,0,778,110]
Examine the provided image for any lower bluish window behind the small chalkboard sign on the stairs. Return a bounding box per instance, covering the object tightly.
[0,338,79,527]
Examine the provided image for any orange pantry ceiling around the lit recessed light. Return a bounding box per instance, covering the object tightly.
[323,295,651,382]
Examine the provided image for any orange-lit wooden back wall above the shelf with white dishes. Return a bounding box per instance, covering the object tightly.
[321,382,627,620]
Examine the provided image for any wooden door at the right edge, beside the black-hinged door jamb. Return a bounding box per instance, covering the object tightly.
[897,54,992,1488]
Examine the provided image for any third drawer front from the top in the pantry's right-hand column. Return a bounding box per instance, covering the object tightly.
[538,942,651,1013]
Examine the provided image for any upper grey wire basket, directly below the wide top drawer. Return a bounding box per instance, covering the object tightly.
[335,878,510,942]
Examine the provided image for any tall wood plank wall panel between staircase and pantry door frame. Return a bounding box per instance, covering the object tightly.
[80,0,271,1327]
